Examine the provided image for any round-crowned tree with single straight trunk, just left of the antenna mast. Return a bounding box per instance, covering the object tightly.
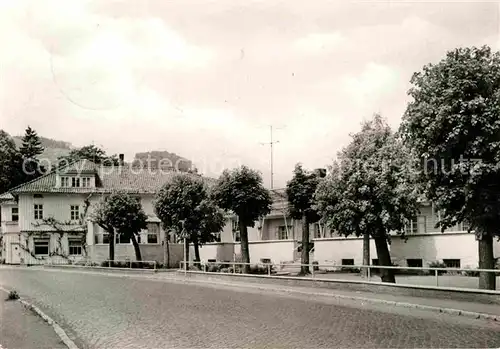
[211,166,272,273]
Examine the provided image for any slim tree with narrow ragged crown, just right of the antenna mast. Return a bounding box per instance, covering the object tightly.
[286,164,326,274]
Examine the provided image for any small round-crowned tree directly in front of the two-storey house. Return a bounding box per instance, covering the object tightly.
[92,192,148,261]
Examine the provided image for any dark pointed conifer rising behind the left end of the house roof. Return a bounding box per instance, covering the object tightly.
[19,126,45,182]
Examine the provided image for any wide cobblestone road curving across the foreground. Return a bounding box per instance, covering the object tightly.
[0,269,500,348]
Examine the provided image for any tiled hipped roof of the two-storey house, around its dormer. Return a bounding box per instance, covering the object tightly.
[4,161,214,194]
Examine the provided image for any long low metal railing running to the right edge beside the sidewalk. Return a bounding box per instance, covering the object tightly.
[179,261,500,293]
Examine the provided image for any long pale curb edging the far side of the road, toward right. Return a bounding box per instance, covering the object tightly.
[167,279,500,322]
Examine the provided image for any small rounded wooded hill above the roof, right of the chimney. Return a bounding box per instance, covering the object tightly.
[132,151,193,172]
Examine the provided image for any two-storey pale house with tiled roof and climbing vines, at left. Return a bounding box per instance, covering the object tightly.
[0,160,189,264]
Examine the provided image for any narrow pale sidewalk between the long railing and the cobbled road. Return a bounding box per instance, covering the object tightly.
[163,274,500,324]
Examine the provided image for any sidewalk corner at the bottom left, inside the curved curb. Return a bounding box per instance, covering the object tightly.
[0,292,67,349]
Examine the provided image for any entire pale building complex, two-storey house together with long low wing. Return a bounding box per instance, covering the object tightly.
[0,160,500,267]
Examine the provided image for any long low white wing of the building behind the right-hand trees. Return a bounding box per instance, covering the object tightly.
[188,189,500,268]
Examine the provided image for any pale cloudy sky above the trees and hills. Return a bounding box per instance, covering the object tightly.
[0,0,500,187]
